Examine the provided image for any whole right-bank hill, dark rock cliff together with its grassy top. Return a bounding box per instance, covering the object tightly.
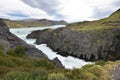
[28,10,120,61]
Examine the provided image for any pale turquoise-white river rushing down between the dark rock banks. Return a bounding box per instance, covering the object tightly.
[10,25,91,69]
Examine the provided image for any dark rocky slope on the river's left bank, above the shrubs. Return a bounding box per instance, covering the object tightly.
[0,19,47,59]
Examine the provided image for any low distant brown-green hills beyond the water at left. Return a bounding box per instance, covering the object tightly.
[3,19,67,28]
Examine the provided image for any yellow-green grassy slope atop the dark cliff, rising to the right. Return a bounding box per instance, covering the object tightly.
[68,9,120,31]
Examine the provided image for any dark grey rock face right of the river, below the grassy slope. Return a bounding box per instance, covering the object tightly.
[29,29,120,60]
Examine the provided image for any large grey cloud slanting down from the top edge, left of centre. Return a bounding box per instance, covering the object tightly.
[22,0,63,18]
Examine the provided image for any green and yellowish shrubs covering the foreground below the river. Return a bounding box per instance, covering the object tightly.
[0,45,120,80]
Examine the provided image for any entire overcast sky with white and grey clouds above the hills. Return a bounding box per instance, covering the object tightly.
[0,0,120,22]
